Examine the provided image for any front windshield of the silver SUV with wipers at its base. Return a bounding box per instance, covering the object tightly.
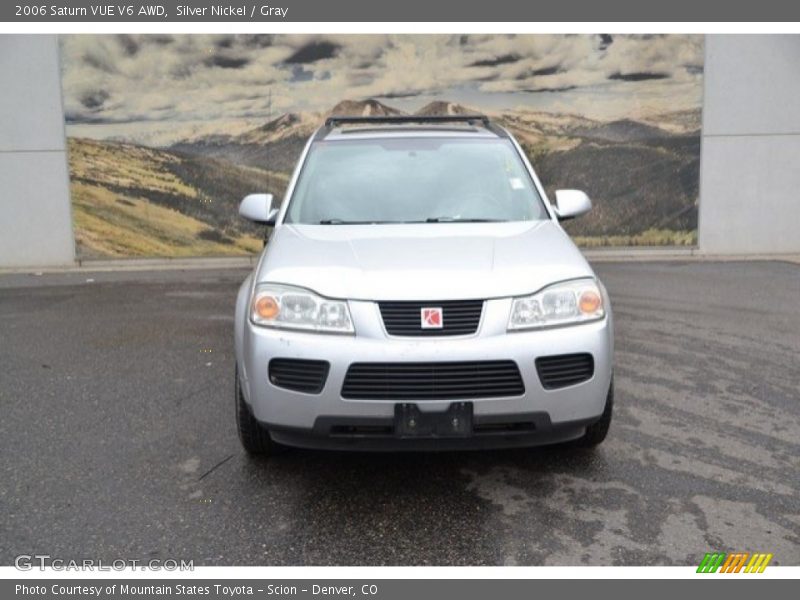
[285,137,548,225]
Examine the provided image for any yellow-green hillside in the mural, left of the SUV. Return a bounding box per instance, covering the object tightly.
[69,138,283,258]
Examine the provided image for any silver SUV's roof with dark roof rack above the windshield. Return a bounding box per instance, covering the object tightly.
[314,115,509,141]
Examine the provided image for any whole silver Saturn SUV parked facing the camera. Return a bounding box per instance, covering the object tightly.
[235,115,614,454]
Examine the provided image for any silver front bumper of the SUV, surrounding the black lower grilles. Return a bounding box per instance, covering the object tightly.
[237,298,614,449]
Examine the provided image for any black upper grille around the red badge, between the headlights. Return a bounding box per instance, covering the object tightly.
[378,300,483,337]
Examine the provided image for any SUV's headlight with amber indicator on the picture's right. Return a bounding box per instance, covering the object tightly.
[508,279,606,331]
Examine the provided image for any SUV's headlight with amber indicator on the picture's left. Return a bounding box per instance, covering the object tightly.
[250,283,353,333]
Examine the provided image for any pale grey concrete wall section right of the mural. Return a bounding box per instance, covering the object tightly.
[698,35,800,254]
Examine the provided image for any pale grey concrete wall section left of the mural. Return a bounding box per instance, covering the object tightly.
[0,35,75,268]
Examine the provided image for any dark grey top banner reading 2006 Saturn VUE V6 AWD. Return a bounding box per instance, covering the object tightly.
[0,0,800,23]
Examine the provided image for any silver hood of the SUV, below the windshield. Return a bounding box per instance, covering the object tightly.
[257,221,593,300]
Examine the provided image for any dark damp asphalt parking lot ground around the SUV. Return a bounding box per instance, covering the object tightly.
[0,262,800,565]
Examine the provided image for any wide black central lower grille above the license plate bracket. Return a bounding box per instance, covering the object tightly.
[342,360,525,400]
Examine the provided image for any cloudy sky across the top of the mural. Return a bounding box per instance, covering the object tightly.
[62,34,703,141]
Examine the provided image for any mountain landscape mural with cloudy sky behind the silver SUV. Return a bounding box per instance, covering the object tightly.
[61,34,703,258]
